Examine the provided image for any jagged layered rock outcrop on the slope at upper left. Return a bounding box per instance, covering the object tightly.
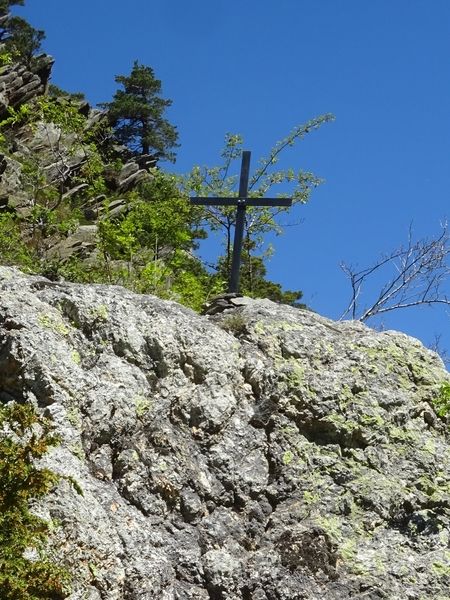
[0,53,157,263]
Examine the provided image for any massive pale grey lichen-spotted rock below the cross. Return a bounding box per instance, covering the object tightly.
[0,267,450,600]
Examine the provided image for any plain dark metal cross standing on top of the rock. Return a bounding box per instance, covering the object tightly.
[190,150,292,293]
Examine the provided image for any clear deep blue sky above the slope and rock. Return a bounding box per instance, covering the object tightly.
[17,0,450,356]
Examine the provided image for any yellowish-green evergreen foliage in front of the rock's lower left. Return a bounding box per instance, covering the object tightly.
[0,403,68,600]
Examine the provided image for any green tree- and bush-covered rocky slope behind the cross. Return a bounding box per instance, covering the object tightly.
[0,0,332,310]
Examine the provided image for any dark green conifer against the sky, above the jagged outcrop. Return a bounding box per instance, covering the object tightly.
[102,61,178,161]
